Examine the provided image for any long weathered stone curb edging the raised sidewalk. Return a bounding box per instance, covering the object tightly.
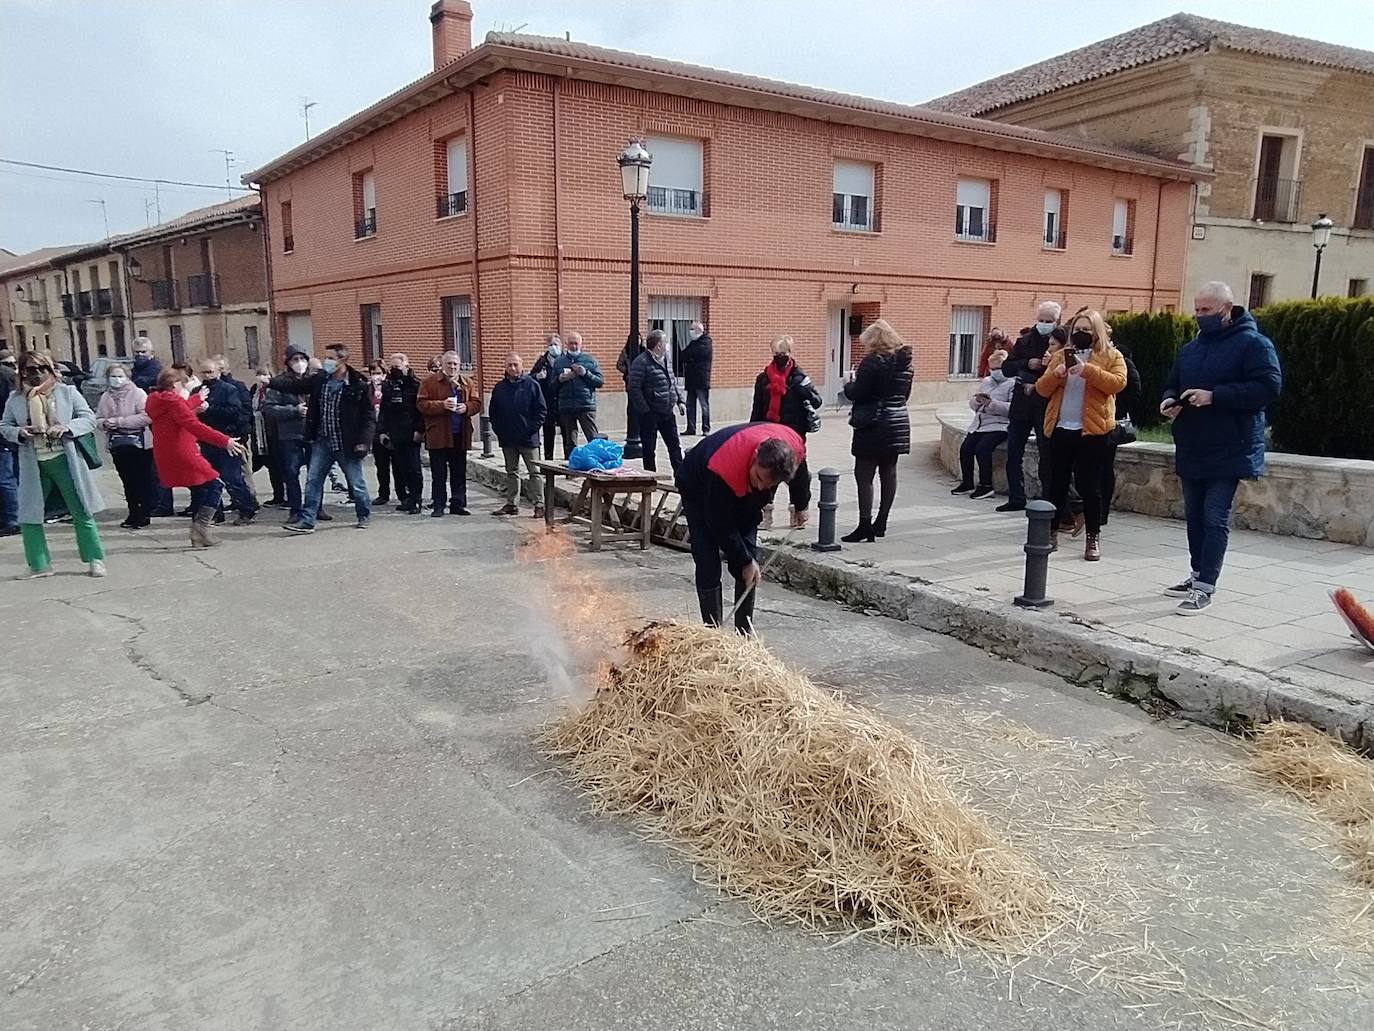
[467,456,1374,755]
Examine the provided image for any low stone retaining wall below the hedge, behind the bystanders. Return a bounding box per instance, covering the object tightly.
[936,404,1374,546]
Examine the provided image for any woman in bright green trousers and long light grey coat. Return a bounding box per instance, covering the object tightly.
[0,351,104,580]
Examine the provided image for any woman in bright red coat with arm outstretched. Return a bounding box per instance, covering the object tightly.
[146,368,247,547]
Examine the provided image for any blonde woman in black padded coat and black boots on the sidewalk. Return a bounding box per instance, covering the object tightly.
[841,319,915,544]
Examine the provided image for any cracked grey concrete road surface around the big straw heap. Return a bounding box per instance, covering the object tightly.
[0,470,1374,1031]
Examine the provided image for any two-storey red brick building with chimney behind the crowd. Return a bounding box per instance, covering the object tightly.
[245,0,1198,418]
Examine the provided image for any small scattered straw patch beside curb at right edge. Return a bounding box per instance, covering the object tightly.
[1253,720,1374,888]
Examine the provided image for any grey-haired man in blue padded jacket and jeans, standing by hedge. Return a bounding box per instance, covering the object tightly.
[1160,282,1283,616]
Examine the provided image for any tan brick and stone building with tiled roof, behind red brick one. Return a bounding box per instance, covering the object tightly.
[929,14,1374,307]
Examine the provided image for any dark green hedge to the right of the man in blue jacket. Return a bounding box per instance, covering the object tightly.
[1254,297,1374,459]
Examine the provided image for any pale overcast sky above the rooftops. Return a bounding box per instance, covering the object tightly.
[0,0,1374,253]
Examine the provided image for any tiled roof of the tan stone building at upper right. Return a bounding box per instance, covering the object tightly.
[926,14,1374,115]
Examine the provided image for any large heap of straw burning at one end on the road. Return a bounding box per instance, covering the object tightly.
[545,623,1055,946]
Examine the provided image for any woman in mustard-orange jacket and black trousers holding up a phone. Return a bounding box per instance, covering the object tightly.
[1035,308,1125,562]
